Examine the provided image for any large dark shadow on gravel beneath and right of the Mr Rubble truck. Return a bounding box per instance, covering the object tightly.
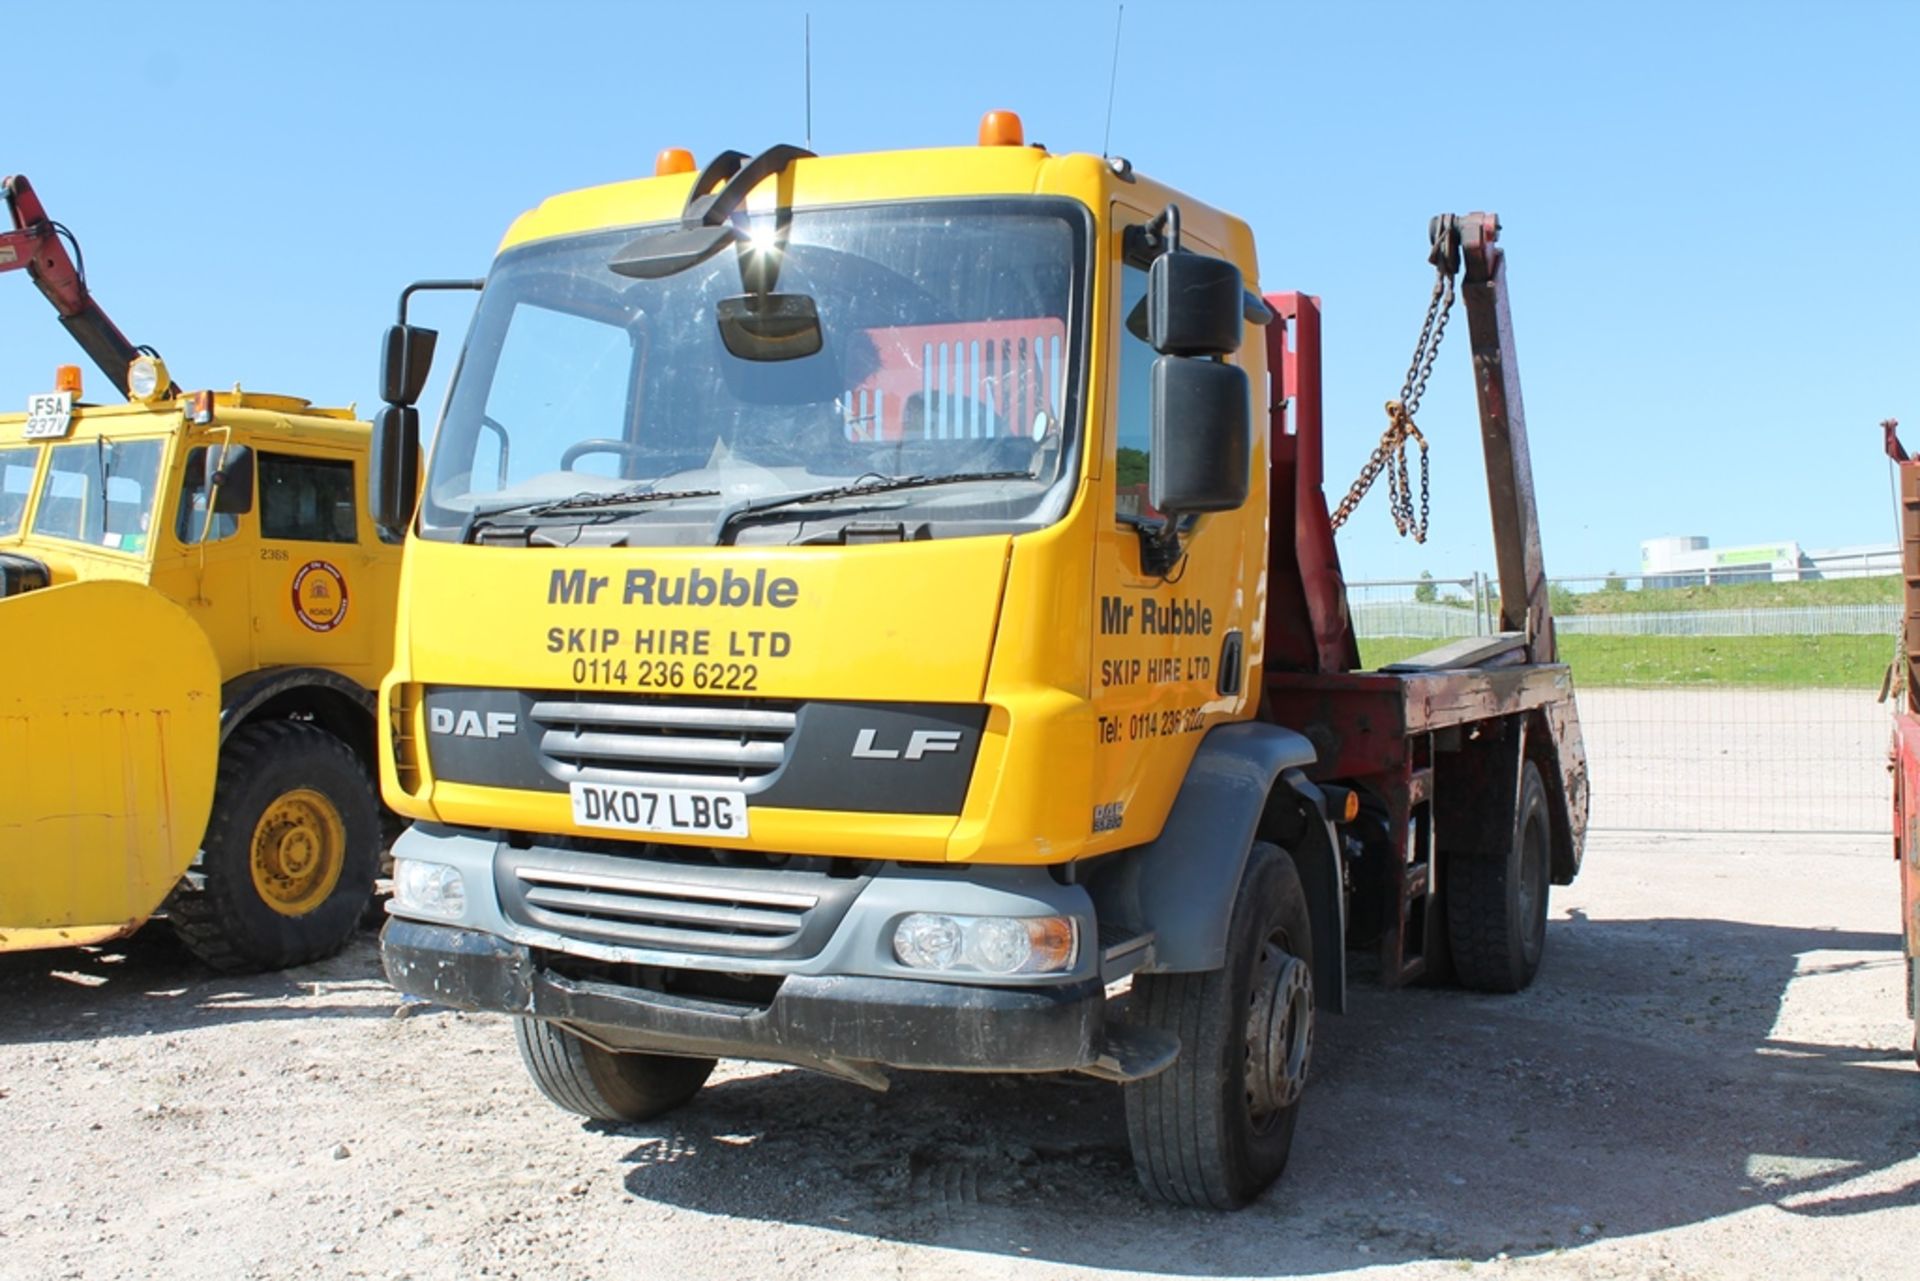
[614,918,1920,1275]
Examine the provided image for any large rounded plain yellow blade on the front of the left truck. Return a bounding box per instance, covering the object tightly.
[0,582,221,953]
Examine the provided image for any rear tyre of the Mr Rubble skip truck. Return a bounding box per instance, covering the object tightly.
[1444,761,1553,991]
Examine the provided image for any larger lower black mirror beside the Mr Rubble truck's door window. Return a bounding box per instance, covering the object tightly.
[1146,355,1254,514]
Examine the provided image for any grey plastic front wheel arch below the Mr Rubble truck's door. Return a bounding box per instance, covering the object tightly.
[1087,720,1346,1012]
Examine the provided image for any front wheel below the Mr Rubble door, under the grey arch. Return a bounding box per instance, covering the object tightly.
[1125,841,1313,1210]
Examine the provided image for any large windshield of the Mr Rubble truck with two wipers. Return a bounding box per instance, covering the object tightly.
[420,198,1087,545]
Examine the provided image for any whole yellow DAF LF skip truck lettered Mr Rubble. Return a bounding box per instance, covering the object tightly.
[369,113,1586,1208]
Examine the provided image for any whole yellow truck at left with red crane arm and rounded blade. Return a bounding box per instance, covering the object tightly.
[0,177,401,970]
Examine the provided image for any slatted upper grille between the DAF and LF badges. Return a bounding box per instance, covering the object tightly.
[532,695,799,791]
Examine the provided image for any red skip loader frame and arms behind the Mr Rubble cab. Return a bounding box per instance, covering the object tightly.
[1261,213,1588,985]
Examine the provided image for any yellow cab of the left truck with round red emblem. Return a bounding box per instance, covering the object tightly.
[0,388,399,688]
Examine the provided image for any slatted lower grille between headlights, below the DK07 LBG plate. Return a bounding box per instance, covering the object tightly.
[493,849,868,958]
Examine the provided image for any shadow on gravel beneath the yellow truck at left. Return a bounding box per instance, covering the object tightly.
[0,924,397,1045]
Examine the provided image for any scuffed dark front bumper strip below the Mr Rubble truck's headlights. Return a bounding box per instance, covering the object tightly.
[380,918,1106,1074]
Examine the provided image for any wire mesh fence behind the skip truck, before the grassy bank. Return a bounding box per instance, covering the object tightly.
[1348,572,1901,834]
